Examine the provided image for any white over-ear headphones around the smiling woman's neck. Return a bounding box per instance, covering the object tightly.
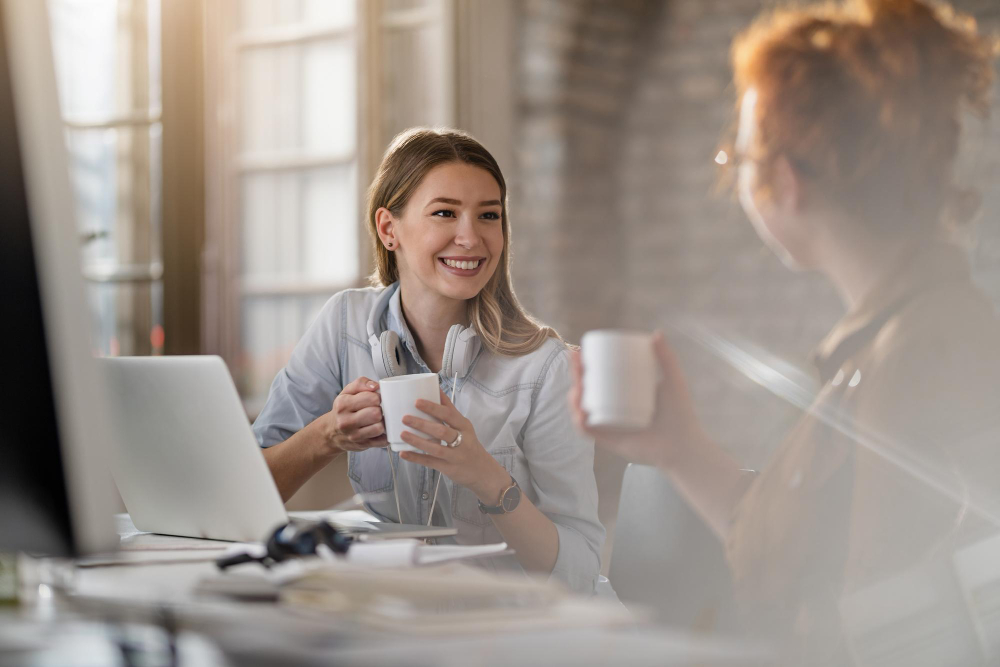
[367,283,482,380]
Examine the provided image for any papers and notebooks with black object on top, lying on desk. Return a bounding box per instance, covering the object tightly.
[107,517,636,635]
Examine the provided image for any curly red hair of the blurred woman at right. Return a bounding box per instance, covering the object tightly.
[732,0,997,233]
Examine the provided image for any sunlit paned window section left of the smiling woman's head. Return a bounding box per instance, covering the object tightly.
[204,0,361,410]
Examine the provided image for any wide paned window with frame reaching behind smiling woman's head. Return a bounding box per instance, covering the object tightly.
[203,0,468,413]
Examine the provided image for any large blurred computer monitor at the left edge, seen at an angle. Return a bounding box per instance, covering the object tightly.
[0,0,117,555]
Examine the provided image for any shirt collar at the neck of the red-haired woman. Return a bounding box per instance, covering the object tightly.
[812,241,971,382]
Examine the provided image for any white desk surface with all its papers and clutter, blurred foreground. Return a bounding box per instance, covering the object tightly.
[0,516,767,667]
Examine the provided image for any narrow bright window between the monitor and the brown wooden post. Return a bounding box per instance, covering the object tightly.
[48,0,164,355]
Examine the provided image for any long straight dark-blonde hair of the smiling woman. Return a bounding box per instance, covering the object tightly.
[368,128,562,356]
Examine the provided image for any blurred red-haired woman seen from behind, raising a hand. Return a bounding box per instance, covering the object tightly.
[571,0,1000,664]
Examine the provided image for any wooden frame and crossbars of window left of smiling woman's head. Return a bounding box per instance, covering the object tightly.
[201,0,370,396]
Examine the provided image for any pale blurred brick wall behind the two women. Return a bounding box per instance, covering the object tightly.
[510,0,1000,466]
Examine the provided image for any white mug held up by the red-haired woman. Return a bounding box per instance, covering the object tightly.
[581,329,660,430]
